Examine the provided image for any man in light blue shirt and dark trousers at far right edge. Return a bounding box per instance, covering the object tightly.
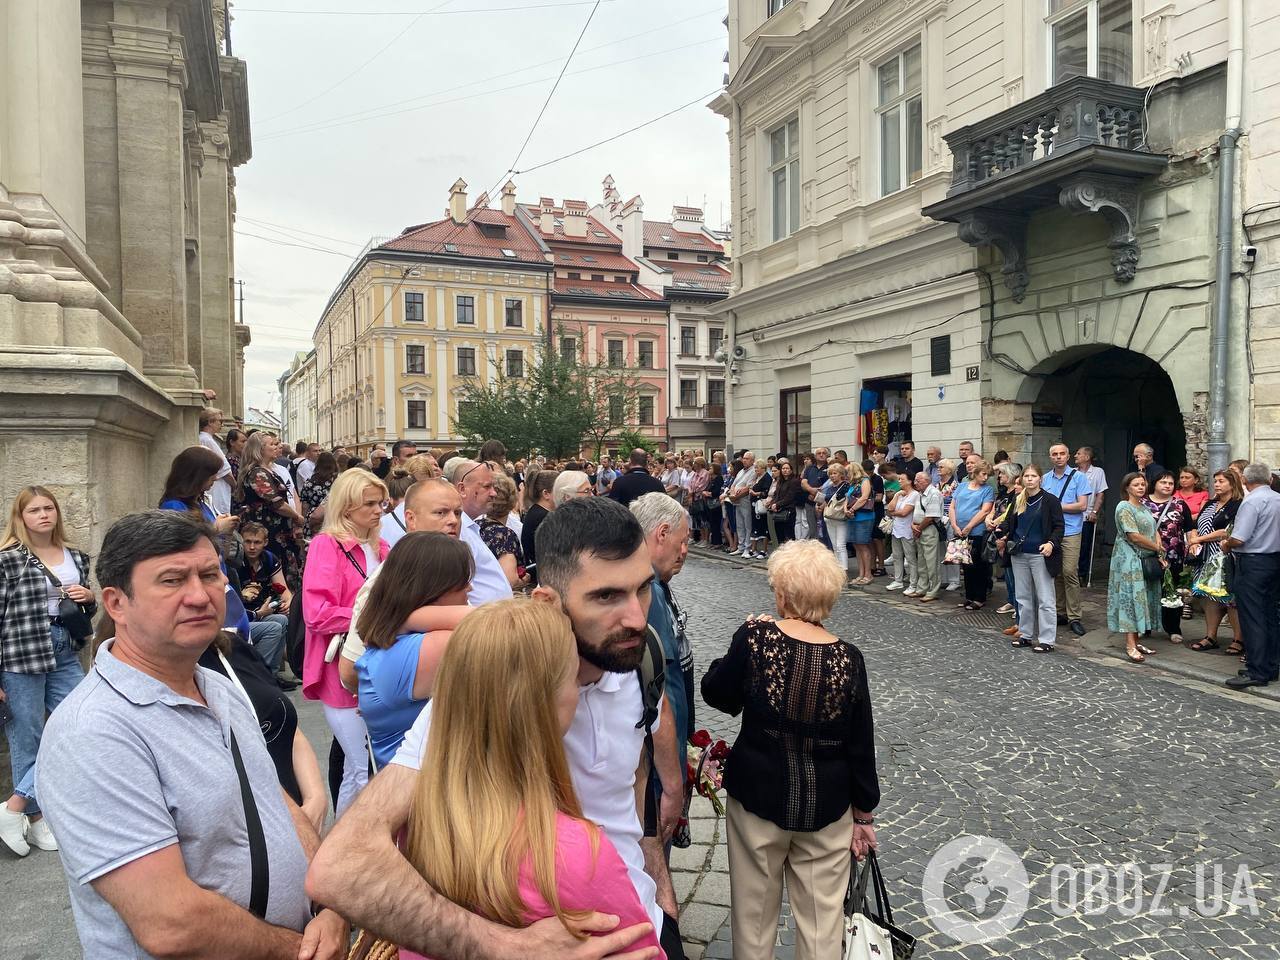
[1222,463,1280,690]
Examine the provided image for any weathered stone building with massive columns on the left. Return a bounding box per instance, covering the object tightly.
[0,0,251,548]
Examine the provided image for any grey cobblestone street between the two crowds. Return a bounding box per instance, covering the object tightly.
[0,556,1280,960]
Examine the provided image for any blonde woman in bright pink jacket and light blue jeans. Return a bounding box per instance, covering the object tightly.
[302,468,388,817]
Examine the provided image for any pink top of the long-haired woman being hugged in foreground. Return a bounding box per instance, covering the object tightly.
[399,814,667,960]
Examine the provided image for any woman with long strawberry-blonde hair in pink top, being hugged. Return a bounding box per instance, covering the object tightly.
[399,599,666,960]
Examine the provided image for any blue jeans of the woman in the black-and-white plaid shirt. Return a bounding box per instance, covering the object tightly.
[0,623,84,817]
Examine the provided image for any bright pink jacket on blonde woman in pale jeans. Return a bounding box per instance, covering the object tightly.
[302,534,389,708]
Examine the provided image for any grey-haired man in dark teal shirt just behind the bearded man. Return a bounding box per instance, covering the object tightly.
[631,493,694,771]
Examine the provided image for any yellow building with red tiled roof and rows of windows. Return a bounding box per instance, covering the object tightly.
[313,180,552,456]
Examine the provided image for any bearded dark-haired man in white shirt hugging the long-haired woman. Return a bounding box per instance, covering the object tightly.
[307,497,682,960]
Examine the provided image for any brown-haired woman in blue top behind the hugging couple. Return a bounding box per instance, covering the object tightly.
[356,531,475,768]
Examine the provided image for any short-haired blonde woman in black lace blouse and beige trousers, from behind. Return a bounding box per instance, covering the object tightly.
[703,540,879,960]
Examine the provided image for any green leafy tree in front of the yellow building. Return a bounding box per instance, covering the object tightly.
[453,340,637,458]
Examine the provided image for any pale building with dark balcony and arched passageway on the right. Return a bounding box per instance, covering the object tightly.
[713,0,1280,476]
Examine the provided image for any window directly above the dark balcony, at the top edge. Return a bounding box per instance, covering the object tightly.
[1046,0,1133,86]
